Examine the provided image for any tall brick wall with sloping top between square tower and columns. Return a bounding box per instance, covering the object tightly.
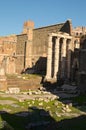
[32,21,71,74]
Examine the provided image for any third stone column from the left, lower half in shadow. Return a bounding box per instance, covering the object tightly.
[61,38,67,78]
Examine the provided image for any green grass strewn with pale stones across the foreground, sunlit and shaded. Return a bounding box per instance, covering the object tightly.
[0,95,86,130]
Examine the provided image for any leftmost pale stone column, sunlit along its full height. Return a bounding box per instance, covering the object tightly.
[46,35,52,80]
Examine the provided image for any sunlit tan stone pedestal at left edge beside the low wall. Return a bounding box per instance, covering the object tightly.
[0,68,7,91]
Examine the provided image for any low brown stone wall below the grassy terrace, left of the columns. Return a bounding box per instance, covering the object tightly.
[7,75,42,90]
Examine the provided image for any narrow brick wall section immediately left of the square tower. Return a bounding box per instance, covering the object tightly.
[16,34,27,73]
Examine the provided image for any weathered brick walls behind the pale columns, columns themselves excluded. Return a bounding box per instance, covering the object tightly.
[0,20,86,84]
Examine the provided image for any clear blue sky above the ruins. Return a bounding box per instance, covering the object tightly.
[0,0,86,36]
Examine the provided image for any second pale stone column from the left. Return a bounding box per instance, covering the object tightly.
[54,38,60,79]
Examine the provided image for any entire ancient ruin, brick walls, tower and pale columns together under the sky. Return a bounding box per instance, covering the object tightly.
[0,20,86,90]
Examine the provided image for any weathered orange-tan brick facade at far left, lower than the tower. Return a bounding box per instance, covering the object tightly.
[0,35,17,74]
